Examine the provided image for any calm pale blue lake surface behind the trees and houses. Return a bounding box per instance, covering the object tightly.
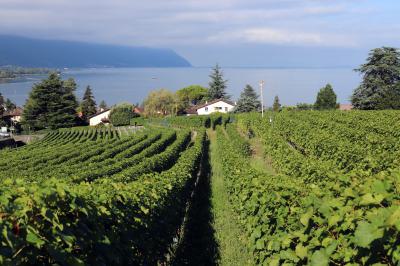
[0,67,361,106]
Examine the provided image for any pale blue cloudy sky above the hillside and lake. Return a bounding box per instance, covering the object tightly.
[0,0,400,67]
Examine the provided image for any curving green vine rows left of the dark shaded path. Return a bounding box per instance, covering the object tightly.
[0,125,205,265]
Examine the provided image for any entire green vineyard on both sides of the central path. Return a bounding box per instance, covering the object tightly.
[0,111,400,265]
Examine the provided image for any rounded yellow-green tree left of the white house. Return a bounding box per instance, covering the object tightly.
[144,89,177,116]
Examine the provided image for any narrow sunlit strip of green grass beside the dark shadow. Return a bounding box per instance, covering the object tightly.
[208,130,252,265]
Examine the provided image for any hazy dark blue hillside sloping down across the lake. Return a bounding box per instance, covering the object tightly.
[0,35,191,68]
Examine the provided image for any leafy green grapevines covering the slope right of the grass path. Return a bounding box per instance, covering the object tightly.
[231,112,400,265]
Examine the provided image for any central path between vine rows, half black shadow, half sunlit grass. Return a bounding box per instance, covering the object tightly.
[171,129,253,266]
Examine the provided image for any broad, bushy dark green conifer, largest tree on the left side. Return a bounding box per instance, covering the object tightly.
[22,73,78,129]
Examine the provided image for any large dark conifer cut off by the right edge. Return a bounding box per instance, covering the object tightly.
[351,47,400,110]
